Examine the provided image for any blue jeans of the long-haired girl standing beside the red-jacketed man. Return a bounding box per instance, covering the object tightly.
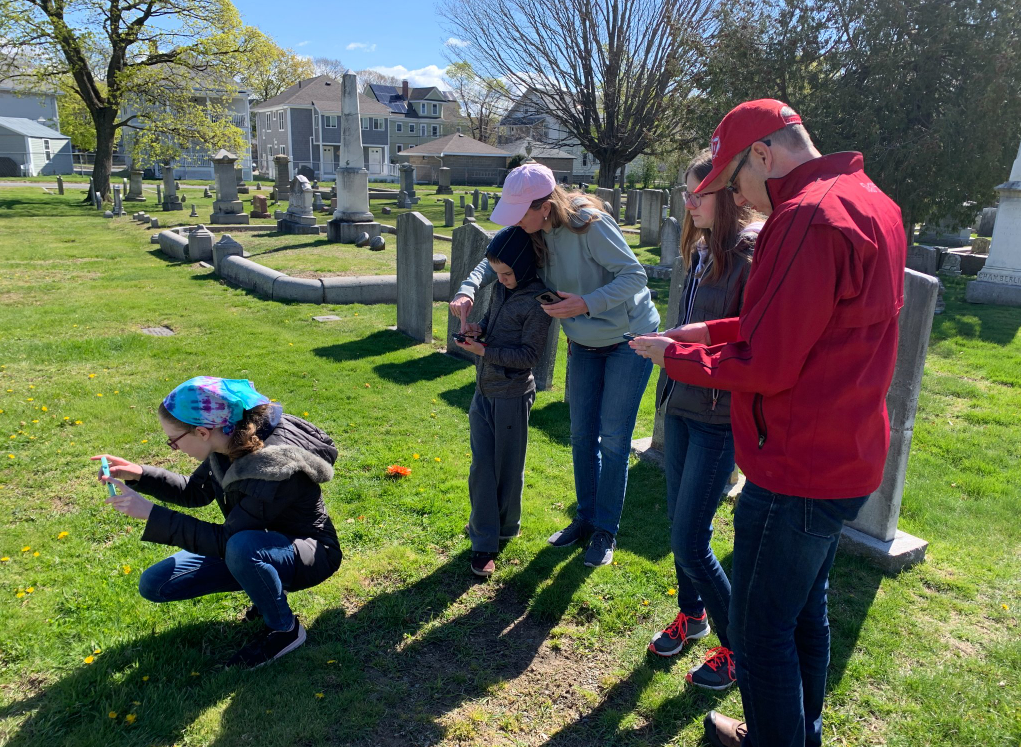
[664,415,734,648]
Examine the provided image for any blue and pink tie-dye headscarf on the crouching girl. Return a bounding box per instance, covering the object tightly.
[163,377,270,435]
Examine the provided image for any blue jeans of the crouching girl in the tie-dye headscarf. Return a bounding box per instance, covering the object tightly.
[138,531,297,631]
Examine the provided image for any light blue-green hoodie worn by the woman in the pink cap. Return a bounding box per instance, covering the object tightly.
[457,208,660,348]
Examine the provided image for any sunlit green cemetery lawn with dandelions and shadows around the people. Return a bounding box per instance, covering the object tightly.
[0,189,1021,747]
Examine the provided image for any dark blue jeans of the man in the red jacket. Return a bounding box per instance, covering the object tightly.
[729,482,868,747]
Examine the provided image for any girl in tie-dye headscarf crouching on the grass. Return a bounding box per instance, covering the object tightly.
[92,377,341,666]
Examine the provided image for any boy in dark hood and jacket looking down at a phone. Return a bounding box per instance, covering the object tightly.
[457,227,552,577]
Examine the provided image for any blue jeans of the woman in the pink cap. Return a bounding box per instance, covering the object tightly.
[568,343,652,535]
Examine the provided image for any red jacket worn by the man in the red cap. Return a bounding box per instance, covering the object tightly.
[666,153,907,498]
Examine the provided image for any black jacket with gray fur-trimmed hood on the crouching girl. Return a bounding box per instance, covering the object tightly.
[129,414,342,590]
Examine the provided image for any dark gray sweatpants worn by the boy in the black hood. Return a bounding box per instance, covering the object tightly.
[468,391,535,552]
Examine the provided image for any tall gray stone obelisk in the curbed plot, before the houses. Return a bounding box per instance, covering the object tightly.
[327,72,379,243]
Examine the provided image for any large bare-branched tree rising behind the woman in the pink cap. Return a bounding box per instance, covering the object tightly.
[439,0,713,187]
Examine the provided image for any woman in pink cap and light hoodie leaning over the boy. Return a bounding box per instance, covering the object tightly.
[450,163,660,567]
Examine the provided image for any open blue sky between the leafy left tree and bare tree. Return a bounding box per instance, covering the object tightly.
[234,0,457,88]
